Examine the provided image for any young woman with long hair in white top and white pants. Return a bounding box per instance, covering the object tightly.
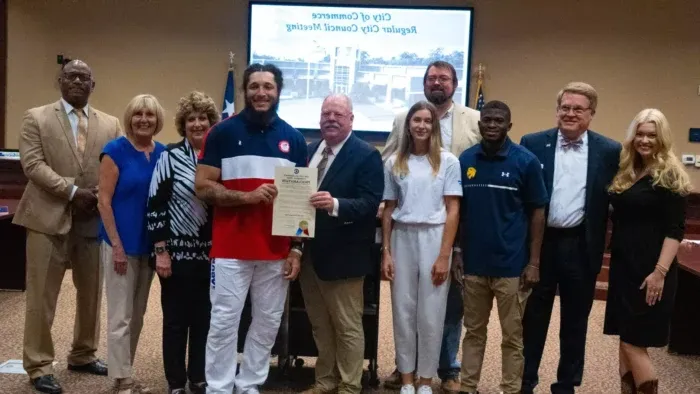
[382,101,462,394]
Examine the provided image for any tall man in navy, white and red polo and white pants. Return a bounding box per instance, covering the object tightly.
[195,64,308,394]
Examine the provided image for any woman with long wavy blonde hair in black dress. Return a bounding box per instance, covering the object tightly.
[604,109,691,393]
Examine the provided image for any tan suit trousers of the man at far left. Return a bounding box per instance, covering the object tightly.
[23,229,102,379]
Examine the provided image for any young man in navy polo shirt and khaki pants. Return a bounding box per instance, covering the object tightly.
[459,101,548,394]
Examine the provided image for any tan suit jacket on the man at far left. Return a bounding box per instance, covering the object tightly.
[12,100,122,237]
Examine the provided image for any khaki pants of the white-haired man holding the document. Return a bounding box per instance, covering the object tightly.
[299,259,365,394]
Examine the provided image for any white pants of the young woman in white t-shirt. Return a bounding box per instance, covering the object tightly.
[391,223,452,378]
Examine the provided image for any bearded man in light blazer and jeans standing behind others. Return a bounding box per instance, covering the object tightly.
[380,61,481,393]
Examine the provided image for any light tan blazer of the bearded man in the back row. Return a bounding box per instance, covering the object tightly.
[382,103,481,161]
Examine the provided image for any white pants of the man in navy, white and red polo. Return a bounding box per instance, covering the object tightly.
[205,259,289,394]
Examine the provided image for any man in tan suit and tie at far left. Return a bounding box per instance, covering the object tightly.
[13,60,121,394]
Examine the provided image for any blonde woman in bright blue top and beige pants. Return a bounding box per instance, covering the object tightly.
[97,94,165,394]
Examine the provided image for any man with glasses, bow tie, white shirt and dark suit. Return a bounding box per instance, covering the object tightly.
[520,82,621,394]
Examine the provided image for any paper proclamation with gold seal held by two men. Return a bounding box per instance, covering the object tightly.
[272,167,318,238]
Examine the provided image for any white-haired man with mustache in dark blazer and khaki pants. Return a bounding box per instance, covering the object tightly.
[300,95,384,394]
